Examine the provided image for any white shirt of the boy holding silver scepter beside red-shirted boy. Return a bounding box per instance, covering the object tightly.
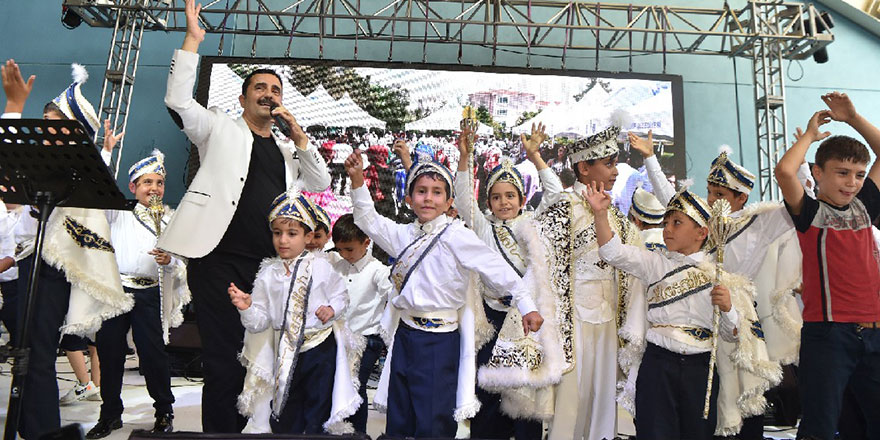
[599,235,739,354]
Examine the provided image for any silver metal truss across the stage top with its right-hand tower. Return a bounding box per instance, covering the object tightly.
[64,0,834,198]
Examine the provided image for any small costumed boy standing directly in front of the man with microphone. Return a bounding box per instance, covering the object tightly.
[230,187,364,434]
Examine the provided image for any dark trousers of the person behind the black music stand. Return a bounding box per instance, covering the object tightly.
[18,257,70,439]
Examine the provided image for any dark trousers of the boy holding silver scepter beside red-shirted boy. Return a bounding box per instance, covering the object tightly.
[636,343,718,440]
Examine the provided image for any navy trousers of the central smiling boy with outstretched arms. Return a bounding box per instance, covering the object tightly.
[385,322,461,438]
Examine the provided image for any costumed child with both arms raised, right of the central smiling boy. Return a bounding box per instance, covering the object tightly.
[455,125,562,440]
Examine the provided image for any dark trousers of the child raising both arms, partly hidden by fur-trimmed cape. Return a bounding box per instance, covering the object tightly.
[471,303,544,440]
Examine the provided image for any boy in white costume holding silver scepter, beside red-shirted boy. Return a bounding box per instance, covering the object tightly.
[600,182,782,440]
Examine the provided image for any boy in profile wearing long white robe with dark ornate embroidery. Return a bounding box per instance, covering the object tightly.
[535,121,642,440]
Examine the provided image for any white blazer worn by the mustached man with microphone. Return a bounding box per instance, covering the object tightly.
[158,50,330,258]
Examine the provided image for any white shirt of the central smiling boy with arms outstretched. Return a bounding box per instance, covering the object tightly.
[351,186,537,315]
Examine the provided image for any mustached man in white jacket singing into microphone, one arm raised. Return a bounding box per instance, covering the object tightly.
[158,1,330,432]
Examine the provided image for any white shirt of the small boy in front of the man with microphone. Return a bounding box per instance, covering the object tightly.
[239,254,348,333]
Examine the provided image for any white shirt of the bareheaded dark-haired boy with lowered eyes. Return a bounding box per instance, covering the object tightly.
[333,250,394,336]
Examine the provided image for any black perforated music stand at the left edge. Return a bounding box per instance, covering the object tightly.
[0,119,137,440]
